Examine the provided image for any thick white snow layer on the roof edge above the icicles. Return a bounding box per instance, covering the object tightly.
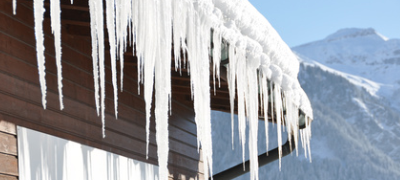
[212,0,313,119]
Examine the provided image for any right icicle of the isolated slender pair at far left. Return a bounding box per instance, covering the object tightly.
[50,0,64,110]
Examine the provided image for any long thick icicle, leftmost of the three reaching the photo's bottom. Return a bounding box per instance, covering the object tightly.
[155,0,172,180]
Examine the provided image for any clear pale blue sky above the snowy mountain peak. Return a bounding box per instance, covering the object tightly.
[249,0,400,47]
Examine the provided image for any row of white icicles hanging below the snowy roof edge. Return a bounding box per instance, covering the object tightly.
[13,0,311,179]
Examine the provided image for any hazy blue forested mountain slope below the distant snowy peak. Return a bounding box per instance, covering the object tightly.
[213,62,400,180]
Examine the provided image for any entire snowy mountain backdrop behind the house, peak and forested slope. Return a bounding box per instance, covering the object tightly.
[213,29,400,180]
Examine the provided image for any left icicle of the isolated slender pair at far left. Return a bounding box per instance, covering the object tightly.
[33,0,47,109]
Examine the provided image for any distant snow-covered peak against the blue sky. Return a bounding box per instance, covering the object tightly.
[292,28,400,110]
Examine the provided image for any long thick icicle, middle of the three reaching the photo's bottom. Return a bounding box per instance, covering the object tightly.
[187,2,213,179]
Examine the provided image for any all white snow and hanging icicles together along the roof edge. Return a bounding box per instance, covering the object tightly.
[13,0,312,179]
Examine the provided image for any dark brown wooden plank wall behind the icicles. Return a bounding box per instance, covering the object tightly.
[0,0,203,179]
